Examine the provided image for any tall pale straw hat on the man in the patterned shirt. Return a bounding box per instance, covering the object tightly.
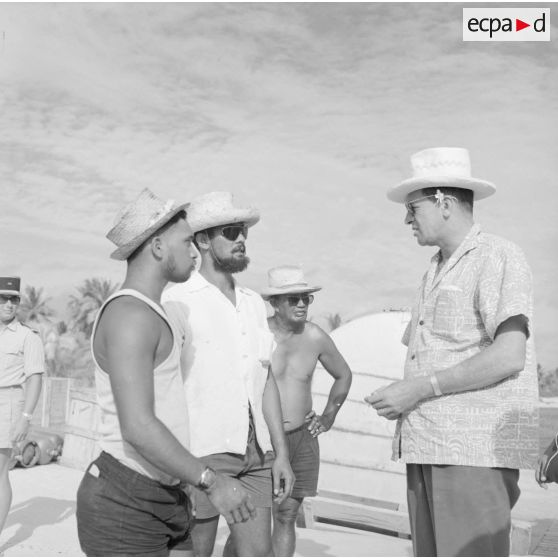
[387,147,496,203]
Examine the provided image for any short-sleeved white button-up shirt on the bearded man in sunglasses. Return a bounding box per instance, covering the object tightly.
[162,272,273,456]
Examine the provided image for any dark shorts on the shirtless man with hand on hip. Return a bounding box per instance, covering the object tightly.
[285,424,320,498]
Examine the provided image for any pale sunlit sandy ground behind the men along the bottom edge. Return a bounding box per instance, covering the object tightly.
[0,464,412,556]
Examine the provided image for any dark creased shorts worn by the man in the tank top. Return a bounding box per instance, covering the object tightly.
[76,452,190,556]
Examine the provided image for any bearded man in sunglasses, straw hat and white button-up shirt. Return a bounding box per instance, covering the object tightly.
[163,192,294,556]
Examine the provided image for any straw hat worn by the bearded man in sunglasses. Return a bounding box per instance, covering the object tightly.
[188,192,260,233]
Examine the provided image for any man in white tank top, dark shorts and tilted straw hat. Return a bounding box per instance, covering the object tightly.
[76,189,255,556]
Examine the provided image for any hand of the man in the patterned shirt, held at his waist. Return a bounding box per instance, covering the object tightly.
[364,378,432,420]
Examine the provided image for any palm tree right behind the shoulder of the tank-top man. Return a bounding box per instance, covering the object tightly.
[68,277,118,338]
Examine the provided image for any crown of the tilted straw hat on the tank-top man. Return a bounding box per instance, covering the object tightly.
[107,188,175,247]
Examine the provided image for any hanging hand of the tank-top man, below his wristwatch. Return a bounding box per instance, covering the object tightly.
[205,473,256,523]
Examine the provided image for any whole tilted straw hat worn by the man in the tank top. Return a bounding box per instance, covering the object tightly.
[107,188,188,260]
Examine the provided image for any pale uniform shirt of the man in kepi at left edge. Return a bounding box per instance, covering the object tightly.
[0,319,45,387]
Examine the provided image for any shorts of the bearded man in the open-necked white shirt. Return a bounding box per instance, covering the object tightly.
[190,420,275,519]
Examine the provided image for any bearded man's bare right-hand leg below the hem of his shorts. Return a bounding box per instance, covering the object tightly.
[230,508,273,556]
